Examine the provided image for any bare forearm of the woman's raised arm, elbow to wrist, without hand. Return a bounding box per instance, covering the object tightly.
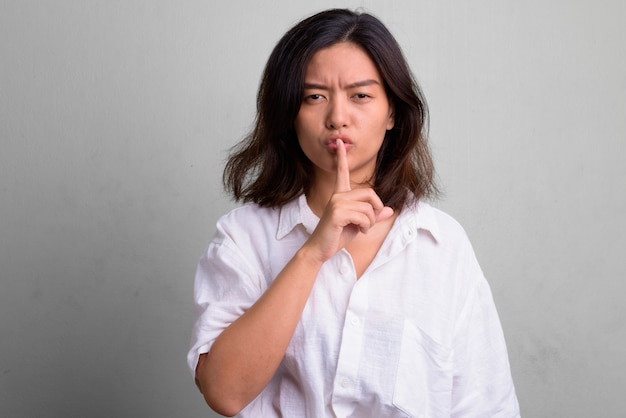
[196,245,323,415]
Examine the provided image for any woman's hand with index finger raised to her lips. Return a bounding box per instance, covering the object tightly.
[308,139,393,261]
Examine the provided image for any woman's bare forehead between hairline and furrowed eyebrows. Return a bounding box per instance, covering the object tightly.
[306,42,381,81]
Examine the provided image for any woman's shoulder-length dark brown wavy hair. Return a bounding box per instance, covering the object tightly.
[223,9,437,211]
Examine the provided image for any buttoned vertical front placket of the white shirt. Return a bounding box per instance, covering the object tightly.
[332,253,368,417]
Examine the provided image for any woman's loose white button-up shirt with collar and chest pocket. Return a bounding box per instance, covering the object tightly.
[188,196,519,418]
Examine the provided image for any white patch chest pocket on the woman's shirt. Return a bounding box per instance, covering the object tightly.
[393,321,453,418]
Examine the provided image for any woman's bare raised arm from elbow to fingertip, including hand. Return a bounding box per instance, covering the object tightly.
[196,143,393,416]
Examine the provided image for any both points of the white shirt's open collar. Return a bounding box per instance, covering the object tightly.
[276,194,441,242]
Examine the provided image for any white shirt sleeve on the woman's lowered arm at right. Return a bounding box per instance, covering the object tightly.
[451,252,520,418]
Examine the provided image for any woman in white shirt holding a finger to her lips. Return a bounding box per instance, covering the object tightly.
[188,10,519,417]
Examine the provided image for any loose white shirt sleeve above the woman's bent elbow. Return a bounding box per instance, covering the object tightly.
[187,229,264,377]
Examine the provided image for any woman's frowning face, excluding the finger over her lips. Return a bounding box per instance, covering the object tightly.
[295,42,394,183]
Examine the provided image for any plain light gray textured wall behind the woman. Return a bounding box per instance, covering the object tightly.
[0,0,626,418]
